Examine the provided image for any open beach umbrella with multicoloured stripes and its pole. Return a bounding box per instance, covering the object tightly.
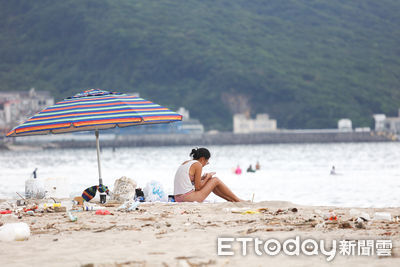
[7,89,182,184]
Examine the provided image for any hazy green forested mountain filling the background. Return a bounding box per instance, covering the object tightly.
[0,0,400,130]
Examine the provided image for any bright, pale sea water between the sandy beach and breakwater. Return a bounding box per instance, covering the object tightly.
[0,142,400,207]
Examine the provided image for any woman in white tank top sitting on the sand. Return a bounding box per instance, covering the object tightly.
[174,148,241,202]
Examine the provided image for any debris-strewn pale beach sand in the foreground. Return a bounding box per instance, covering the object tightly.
[0,201,400,266]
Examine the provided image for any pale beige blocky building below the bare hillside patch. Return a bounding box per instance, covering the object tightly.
[233,113,277,133]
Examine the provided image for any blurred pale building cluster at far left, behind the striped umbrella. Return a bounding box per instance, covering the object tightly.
[0,88,54,133]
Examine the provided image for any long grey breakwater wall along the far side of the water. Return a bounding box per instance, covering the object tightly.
[0,130,399,150]
